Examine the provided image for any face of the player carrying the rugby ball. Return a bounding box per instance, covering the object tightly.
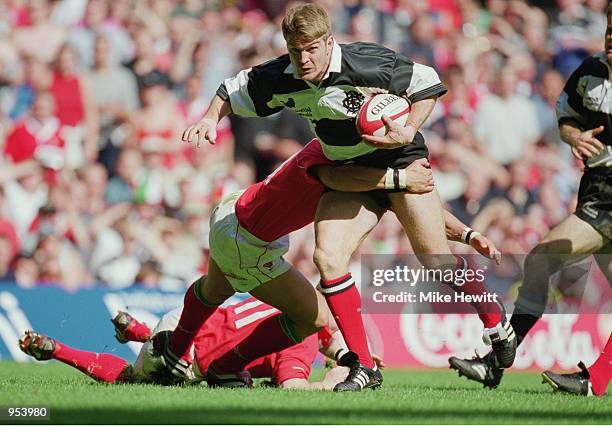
[287,36,334,83]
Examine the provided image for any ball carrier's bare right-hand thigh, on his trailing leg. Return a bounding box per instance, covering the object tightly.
[389,189,454,266]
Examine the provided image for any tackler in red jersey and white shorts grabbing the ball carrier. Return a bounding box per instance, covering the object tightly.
[155,140,499,388]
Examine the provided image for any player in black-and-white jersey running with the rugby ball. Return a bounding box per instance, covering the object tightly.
[183,4,516,390]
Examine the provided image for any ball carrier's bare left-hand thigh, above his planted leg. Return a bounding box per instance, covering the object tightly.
[315,191,384,259]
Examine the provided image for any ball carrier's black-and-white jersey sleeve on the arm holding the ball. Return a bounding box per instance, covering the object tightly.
[389,54,447,103]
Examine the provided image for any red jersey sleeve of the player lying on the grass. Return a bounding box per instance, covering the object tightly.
[274,334,318,385]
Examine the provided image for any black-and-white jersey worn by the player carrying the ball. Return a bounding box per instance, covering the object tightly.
[217,42,446,160]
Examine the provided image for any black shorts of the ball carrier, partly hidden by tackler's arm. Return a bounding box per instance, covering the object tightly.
[351,132,429,210]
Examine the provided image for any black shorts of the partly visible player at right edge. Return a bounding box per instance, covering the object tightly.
[576,167,612,240]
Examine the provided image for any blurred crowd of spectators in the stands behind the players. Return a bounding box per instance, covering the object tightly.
[0,0,607,290]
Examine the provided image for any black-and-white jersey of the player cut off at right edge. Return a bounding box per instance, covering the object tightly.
[557,52,612,166]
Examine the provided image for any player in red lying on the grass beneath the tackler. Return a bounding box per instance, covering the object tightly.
[19,298,381,389]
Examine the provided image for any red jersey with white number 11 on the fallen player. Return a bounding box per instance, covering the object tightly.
[194,297,319,384]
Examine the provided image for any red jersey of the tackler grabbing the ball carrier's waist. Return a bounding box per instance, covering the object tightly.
[236,139,334,242]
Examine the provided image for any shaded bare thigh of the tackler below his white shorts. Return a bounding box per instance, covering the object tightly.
[250,267,329,337]
